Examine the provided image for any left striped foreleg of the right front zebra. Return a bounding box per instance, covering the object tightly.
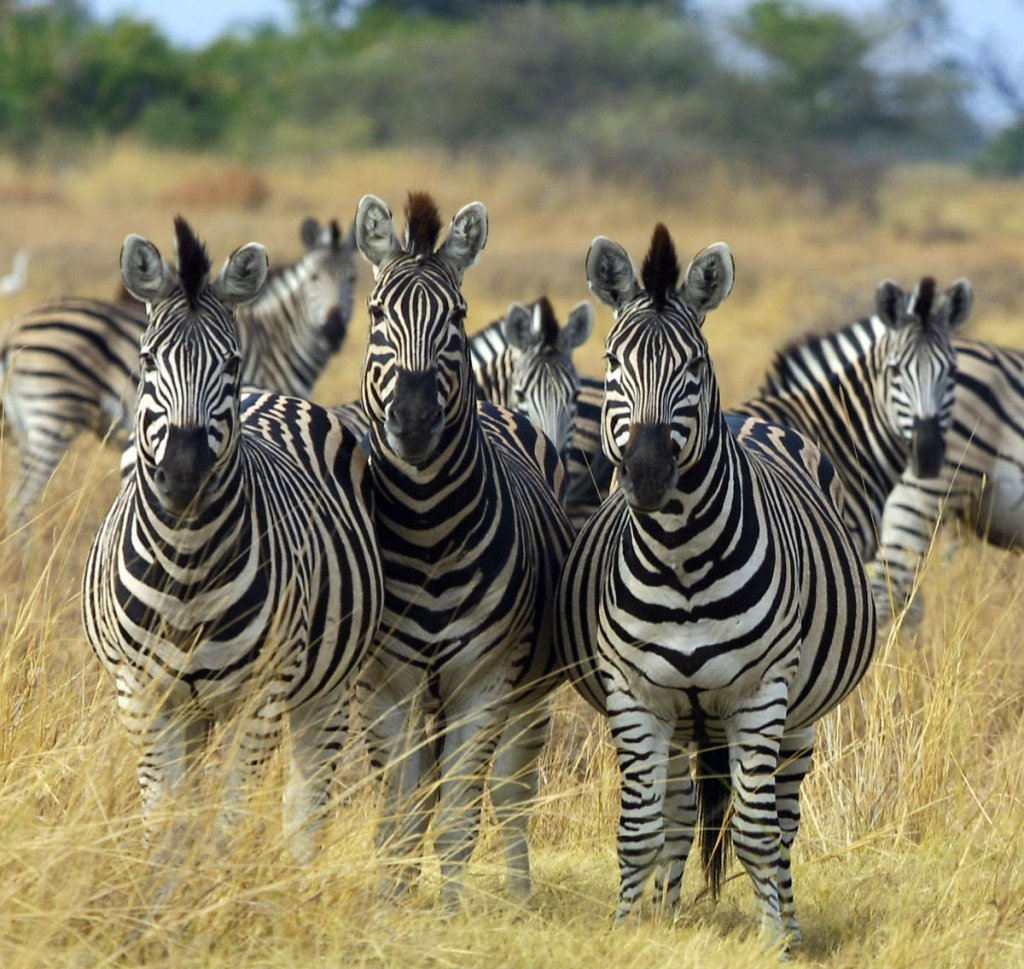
[606,693,674,922]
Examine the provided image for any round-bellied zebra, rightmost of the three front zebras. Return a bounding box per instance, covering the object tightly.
[556,224,876,941]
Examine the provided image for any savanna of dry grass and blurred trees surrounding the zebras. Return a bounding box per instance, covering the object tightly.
[0,0,1024,969]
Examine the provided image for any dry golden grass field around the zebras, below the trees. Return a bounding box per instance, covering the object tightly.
[0,146,1024,969]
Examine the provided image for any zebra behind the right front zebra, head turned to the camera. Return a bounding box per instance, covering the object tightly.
[731,277,973,615]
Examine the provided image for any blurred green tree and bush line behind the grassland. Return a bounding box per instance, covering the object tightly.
[0,0,1024,201]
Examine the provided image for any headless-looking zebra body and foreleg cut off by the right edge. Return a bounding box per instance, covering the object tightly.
[878,337,1024,602]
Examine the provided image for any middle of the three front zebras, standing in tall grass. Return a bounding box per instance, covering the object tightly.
[355,193,571,907]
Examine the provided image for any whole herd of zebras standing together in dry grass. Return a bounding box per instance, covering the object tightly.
[0,193,1024,946]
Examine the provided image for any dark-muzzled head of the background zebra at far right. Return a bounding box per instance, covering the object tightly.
[876,277,973,477]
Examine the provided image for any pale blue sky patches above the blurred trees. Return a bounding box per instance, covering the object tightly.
[88,0,1024,120]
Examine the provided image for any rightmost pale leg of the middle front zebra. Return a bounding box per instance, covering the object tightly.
[489,700,549,899]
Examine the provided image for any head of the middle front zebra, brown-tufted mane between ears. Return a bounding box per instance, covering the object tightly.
[355,193,487,464]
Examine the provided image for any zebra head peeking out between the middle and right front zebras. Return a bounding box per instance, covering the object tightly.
[502,296,594,454]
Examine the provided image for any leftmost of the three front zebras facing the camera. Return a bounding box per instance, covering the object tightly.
[82,217,383,859]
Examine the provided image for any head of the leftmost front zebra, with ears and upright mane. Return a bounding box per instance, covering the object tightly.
[121,216,267,517]
